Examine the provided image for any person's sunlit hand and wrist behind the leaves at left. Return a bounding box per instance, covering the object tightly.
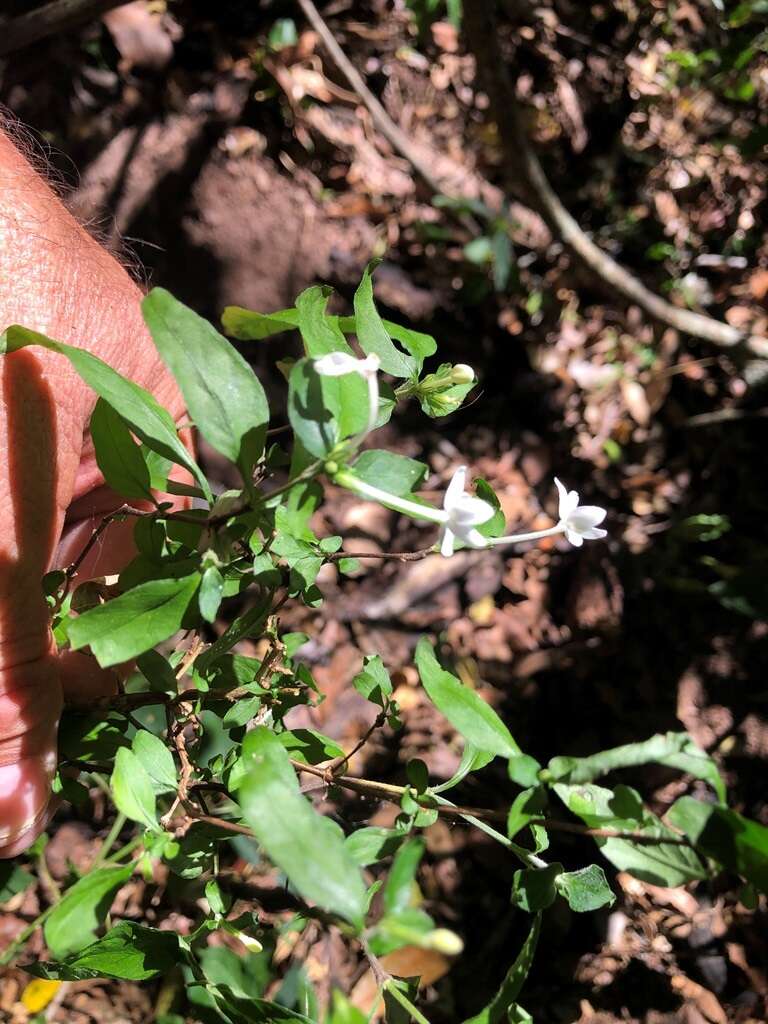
[0,129,183,857]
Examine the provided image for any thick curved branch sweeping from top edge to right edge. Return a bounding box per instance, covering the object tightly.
[464,2,768,357]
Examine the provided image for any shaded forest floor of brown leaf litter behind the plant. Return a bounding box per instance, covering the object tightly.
[0,0,768,1024]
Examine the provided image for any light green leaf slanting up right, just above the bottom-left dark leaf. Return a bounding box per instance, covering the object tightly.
[44,864,133,959]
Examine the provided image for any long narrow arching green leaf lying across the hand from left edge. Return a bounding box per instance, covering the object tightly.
[0,326,213,501]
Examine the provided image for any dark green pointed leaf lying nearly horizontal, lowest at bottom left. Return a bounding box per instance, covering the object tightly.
[24,921,182,981]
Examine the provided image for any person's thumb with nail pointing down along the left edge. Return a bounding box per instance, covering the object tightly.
[0,351,82,856]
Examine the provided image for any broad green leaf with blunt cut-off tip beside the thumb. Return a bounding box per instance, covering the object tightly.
[70,572,200,669]
